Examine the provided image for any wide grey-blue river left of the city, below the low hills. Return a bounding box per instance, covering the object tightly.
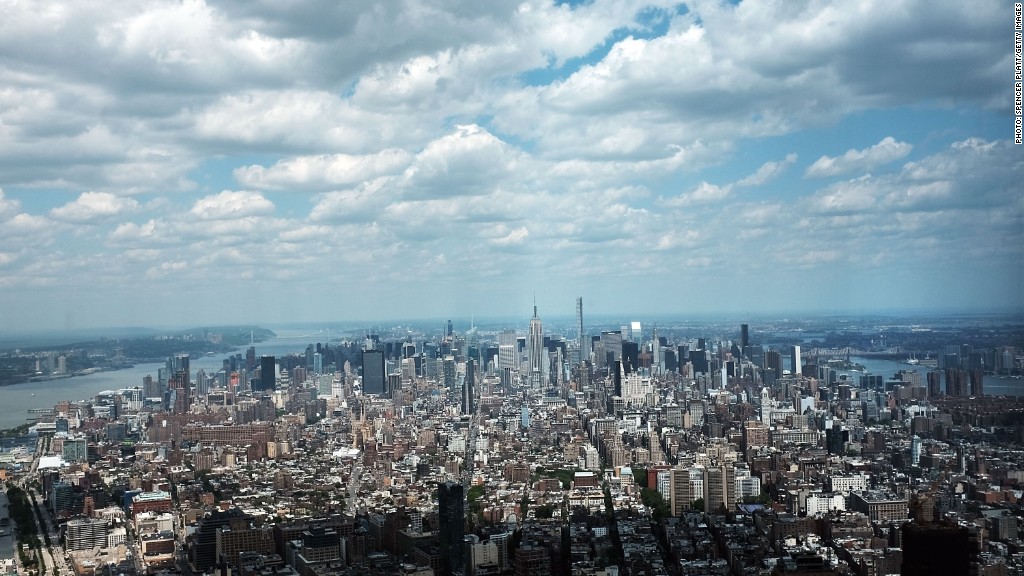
[0,330,323,429]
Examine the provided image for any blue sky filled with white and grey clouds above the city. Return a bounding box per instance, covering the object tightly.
[0,0,1024,331]
